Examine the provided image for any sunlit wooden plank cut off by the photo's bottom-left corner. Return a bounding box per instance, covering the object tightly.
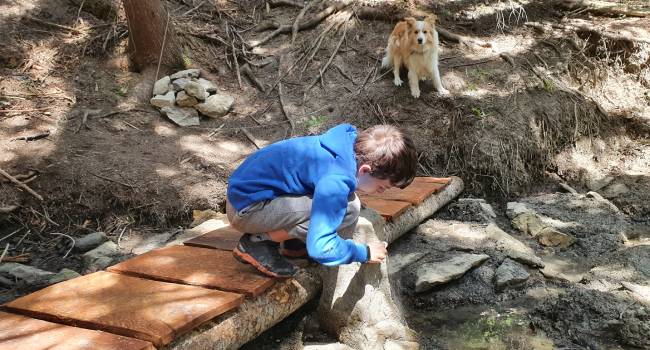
[0,311,156,350]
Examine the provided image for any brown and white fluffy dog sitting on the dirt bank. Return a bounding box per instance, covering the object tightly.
[381,15,449,98]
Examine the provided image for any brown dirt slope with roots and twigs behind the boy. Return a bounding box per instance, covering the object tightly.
[0,0,650,349]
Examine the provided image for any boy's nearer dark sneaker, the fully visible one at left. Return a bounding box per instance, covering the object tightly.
[232,233,298,278]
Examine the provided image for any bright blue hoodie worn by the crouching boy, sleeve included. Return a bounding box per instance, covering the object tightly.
[228,124,368,266]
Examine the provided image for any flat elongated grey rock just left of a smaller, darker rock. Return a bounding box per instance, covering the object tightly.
[415,253,490,293]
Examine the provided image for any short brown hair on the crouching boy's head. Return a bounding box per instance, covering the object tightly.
[354,125,418,188]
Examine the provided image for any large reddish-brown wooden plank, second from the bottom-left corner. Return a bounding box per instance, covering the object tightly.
[4,271,243,346]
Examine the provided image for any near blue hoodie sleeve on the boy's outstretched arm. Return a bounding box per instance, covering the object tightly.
[307,175,368,266]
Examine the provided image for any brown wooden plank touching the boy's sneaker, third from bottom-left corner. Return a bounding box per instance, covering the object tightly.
[107,246,274,297]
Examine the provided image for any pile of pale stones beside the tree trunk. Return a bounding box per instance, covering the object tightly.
[150,69,235,126]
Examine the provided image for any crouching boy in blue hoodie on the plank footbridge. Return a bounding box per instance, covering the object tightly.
[226,124,417,277]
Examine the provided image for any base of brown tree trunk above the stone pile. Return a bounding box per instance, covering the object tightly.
[122,0,183,70]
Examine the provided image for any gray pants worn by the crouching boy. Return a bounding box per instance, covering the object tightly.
[226,193,361,241]
